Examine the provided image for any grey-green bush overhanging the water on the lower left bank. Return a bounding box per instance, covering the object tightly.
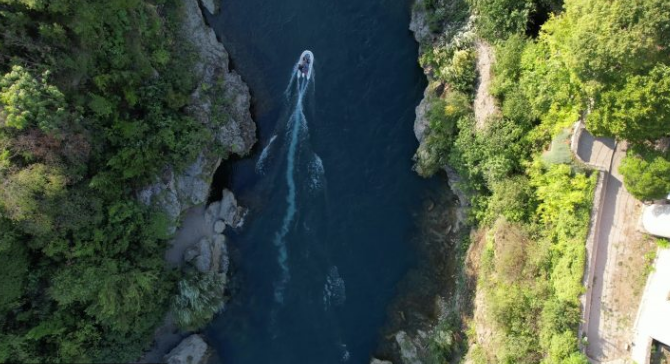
[172,272,226,331]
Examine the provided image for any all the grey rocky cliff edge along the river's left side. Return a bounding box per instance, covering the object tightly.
[137,0,256,364]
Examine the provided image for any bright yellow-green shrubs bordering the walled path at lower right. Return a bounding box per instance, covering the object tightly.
[479,164,595,363]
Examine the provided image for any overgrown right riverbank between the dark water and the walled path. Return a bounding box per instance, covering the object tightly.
[411,0,595,363]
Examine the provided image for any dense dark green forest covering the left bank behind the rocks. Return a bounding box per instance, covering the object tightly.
[0,0,236,363]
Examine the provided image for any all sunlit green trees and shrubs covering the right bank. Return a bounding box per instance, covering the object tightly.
[415,0,670,363]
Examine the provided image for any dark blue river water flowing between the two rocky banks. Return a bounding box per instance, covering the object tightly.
[202,0,439,364]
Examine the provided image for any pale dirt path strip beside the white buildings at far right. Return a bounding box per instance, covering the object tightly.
[585,144,653,363]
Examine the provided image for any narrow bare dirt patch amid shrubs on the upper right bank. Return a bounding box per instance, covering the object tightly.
[475,40,498,130]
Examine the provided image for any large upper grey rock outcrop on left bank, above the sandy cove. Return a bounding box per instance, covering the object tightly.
[138,0,256,233]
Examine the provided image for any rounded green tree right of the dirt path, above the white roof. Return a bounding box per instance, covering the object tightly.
[619,146,670,201]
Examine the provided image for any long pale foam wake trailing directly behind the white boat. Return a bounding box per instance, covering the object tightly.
[274,77,309,303]
